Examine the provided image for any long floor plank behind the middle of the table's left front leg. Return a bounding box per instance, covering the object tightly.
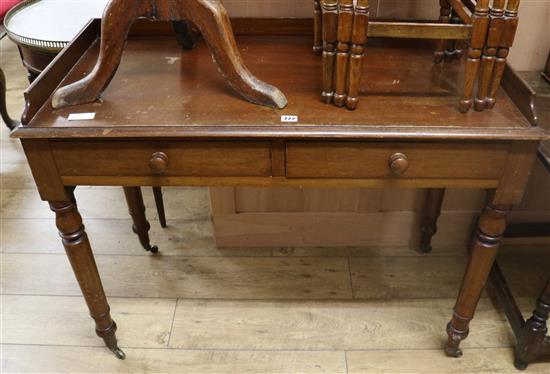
[1,253,352,299]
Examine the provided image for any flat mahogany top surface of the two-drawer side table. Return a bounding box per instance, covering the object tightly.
[14,36,542,140]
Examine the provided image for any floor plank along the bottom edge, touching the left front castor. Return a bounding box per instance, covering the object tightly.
[1,345,346,374]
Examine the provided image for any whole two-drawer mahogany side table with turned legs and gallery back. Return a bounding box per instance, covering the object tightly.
[13,21,547,358]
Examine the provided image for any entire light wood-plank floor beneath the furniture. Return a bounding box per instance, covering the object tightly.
[0,40,550,373]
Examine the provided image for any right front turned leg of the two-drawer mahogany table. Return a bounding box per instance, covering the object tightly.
[445,196,508,357]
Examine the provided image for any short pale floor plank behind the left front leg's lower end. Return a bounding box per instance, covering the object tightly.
[1,295,176,352]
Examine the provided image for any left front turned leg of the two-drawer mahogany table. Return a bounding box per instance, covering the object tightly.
[50,194,125,359]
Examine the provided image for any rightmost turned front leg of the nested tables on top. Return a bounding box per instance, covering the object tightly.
[485,0,520,109]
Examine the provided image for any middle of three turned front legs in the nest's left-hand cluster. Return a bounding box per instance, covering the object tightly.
[333,0,353,106]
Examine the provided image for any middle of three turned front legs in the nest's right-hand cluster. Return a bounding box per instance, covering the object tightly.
[474,0,506,111]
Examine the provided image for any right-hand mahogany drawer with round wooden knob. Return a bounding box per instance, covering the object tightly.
[286,141,508,179]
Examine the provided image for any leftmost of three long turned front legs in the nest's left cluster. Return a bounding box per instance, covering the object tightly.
[321,0,338,104]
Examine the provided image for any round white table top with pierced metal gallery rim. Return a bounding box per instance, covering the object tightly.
[4,0,108,51]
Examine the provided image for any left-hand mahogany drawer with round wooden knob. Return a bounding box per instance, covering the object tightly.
[51,140,271,177]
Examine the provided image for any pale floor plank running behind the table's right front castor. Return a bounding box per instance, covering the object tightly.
[170,299,516,350]
